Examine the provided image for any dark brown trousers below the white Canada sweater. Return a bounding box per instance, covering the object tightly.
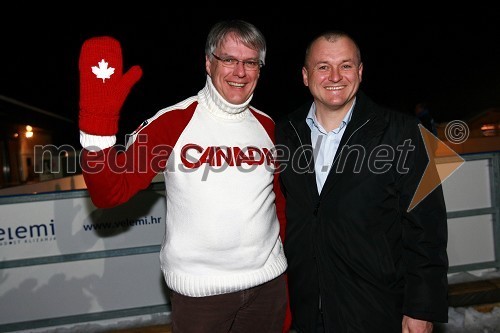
[170,275,287,333]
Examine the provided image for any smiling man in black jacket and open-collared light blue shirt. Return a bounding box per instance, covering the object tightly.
[276,31,448,333]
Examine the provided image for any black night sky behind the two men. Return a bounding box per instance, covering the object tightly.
[0,5,500,143]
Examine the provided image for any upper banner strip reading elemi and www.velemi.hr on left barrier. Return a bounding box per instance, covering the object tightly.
[0,191,165,261]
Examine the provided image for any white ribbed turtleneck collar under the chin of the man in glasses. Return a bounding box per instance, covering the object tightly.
[198,75,253,120]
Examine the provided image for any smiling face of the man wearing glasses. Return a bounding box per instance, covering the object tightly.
[205,34,260,104]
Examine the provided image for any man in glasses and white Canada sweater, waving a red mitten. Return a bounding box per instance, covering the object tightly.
[79,20,287,333]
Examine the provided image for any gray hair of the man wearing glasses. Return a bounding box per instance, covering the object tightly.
[205,20,266,64]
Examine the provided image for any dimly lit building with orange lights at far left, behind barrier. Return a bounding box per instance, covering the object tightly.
[0,95,81,188]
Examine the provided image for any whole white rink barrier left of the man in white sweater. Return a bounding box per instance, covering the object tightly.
[0,190,169,332]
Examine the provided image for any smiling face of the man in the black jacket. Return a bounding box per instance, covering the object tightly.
[302,37,363,112]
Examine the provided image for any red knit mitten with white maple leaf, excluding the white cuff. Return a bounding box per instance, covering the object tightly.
[78,36,142,136]
